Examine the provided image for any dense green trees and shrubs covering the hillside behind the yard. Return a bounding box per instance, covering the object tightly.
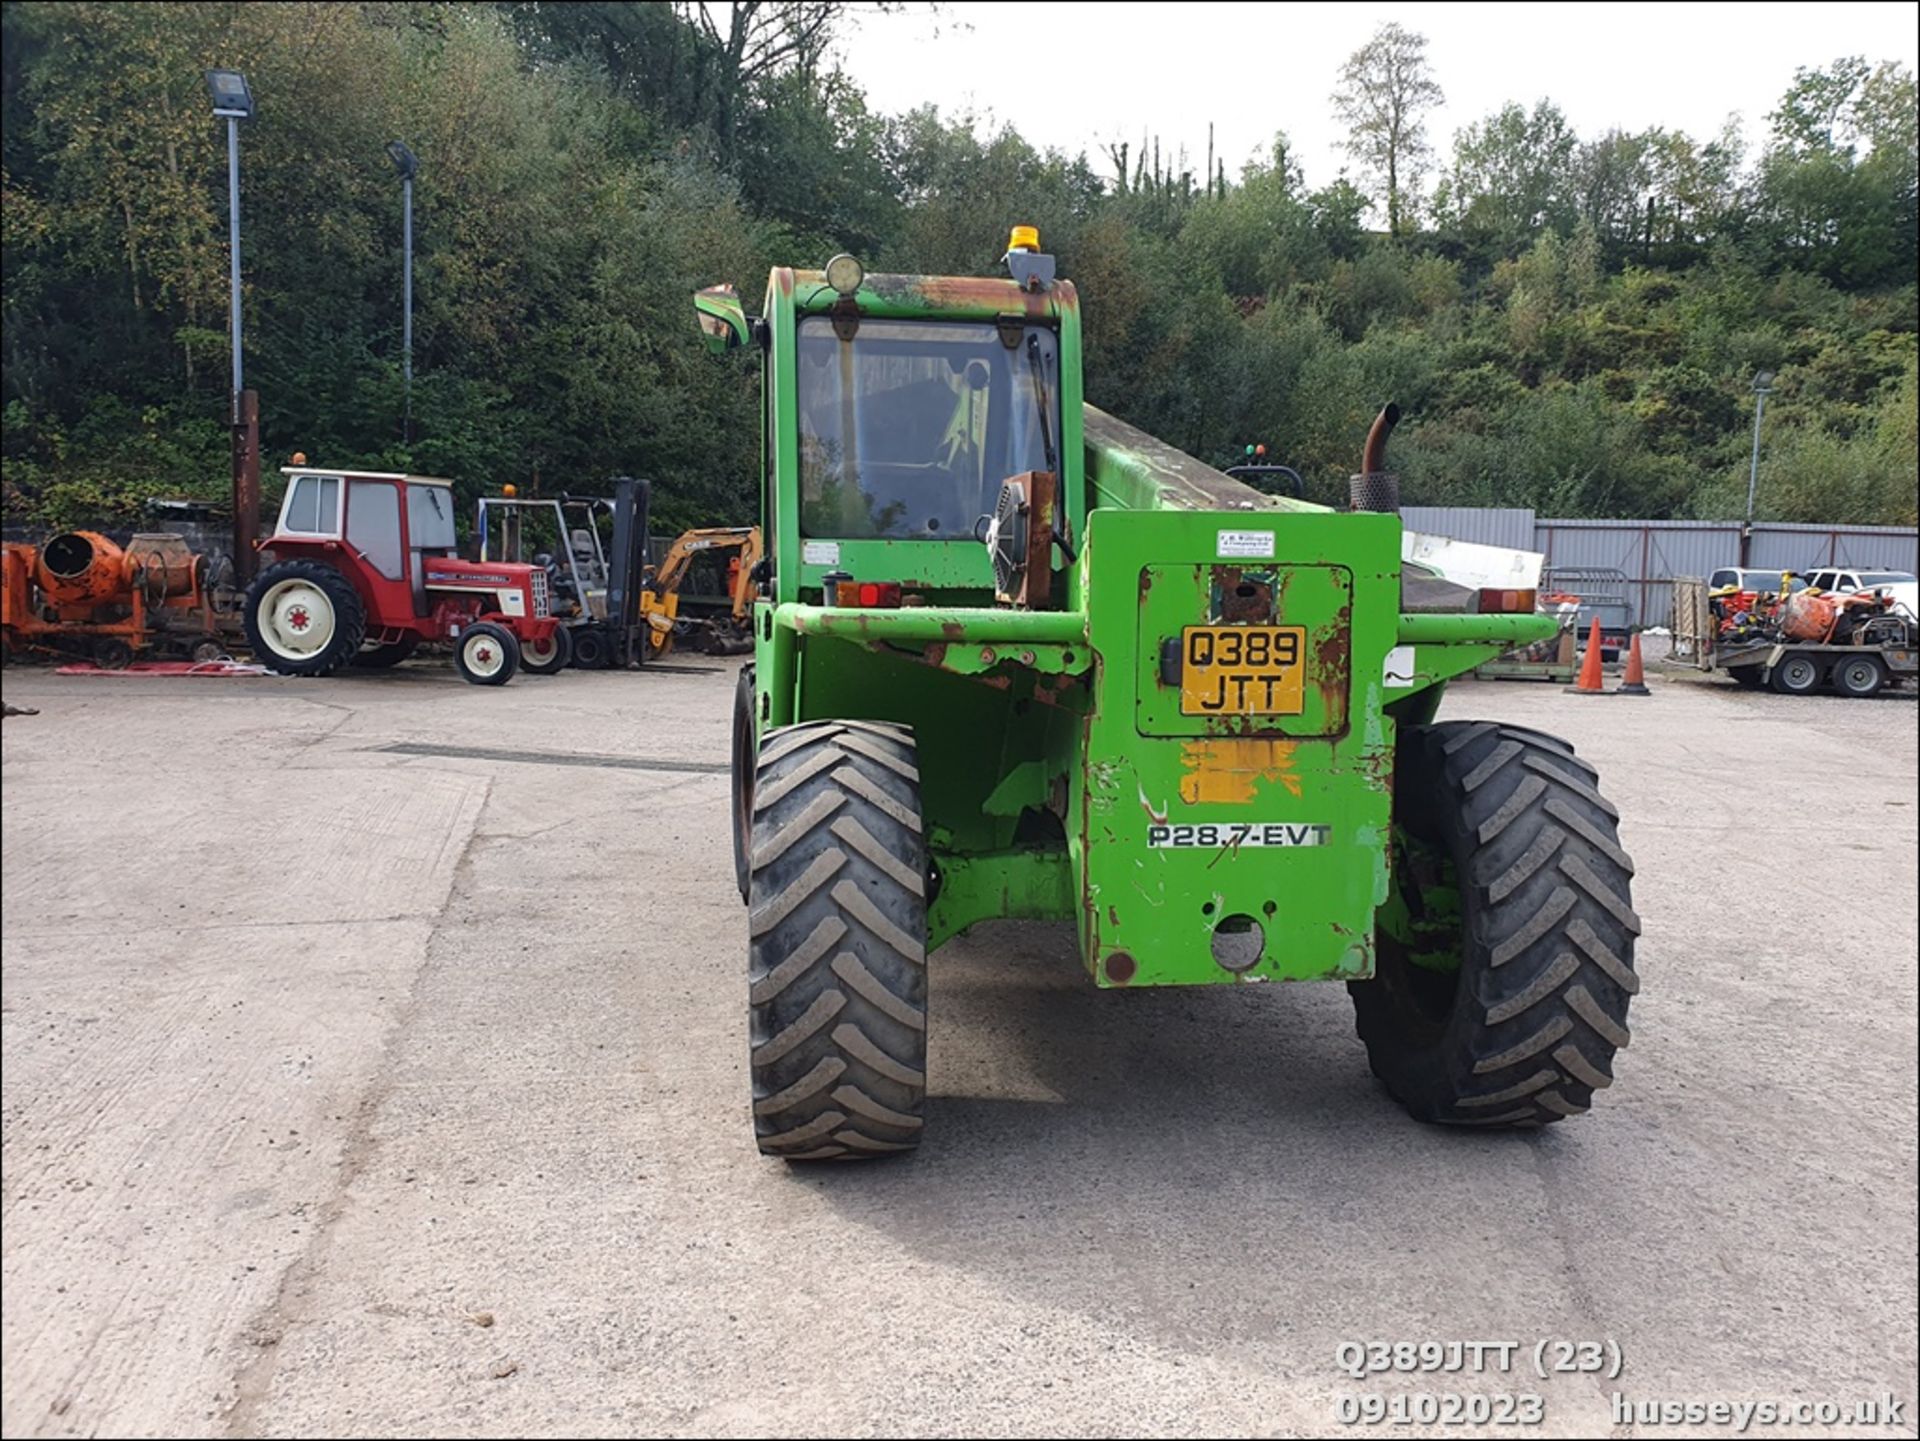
[0,0,1920,530]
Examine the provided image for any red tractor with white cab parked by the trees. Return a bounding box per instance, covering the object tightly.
[246,466,572,685]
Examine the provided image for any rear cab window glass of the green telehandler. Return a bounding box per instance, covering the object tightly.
[799,315,1060,541]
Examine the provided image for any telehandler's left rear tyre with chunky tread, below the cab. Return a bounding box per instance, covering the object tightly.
[747,721,927,1161]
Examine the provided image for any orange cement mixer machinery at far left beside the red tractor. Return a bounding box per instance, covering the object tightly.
[0,530,225,668]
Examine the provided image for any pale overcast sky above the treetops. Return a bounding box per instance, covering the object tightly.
[843,0,1920,186]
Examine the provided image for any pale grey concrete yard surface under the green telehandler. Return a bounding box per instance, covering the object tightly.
[4,660,1916,1435]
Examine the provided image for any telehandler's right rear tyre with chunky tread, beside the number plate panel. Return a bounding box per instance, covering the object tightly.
[1348,721,1640,1126]
